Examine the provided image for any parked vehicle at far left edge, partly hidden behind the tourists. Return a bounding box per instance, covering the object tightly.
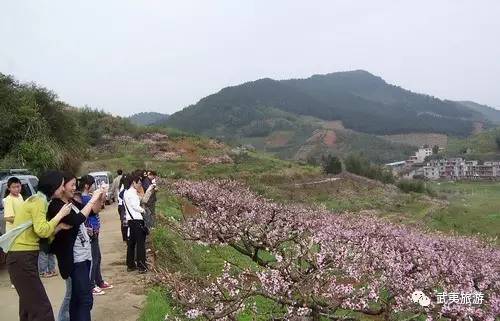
[0,169,38,234]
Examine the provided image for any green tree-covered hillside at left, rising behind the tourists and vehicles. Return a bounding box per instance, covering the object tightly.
[0,73,138,172]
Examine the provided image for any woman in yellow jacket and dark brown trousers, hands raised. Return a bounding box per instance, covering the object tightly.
[7,171,71,321]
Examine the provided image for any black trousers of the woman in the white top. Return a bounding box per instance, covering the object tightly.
[127,220,146,269]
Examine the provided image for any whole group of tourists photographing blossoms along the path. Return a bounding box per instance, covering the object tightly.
[0,170,156,321]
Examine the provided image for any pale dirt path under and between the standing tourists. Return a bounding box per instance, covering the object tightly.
[0,204,145,321]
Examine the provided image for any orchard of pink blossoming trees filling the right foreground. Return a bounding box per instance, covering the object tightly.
[163,180,500,321]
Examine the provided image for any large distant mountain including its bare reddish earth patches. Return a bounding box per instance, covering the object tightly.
[152,70,500,161]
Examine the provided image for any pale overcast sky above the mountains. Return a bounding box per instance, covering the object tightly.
[0,0,500,115]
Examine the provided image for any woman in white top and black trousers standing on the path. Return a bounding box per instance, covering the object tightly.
[123,173,147,273]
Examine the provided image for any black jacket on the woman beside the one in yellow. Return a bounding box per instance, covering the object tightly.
[47,198,87,279]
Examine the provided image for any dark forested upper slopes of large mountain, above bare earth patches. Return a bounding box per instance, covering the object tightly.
[165,70,500,137]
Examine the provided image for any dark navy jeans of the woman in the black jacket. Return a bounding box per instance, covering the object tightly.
[69,261,94,321]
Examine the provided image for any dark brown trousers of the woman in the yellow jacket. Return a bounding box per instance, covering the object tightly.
[7,251,54,321]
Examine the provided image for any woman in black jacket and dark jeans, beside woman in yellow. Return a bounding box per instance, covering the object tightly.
[47,174,104,321]
